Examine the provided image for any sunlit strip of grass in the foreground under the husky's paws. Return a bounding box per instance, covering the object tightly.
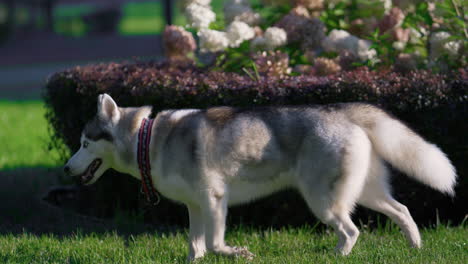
[0,227,468,264]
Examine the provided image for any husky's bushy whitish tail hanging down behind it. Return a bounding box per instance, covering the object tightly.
[346,104,457,196]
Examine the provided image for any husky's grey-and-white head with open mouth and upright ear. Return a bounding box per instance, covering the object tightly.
[64,94,121,185]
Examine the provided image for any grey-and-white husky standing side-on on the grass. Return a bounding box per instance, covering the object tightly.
[65,94,456,260]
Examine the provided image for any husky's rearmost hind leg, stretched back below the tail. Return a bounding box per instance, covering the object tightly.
[358,156,421,248]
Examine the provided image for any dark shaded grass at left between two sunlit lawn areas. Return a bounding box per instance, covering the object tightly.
[0,168,177,237]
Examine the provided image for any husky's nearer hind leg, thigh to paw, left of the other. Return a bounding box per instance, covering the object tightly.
[298,130,371,255]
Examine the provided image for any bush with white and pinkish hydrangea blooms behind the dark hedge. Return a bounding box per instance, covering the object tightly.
[167,0,468,75]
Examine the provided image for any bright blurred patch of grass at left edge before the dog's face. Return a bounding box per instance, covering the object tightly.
[0,100,59,170]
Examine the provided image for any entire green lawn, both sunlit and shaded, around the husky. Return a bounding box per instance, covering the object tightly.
[0,101,468,263]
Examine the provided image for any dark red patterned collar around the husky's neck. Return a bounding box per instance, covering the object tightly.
[137,118,160,204]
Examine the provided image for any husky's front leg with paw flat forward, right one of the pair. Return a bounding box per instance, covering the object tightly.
[204,190,254,259]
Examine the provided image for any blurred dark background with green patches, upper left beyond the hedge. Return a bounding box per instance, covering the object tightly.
[0,0,222,99]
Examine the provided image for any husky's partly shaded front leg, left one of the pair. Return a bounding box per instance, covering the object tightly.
[187,205,206,262]
